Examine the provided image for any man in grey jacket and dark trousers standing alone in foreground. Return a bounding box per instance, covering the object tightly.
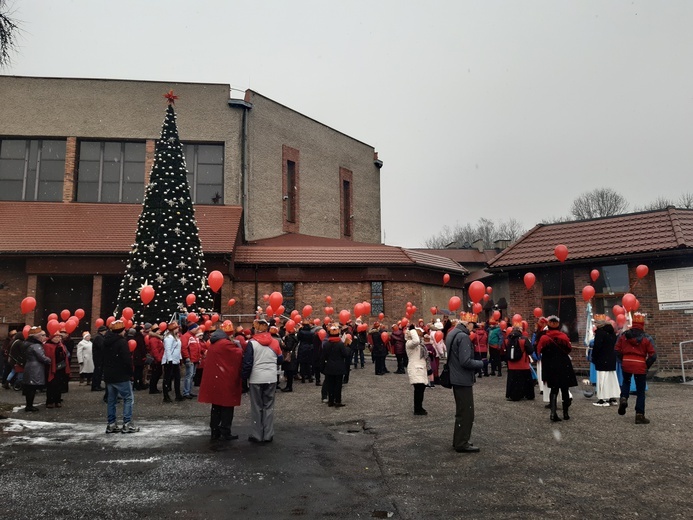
[445,314,484,453]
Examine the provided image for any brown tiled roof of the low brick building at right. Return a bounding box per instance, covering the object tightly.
[489,208,693,269]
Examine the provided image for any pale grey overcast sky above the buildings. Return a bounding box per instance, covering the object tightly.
[2,0,693,247]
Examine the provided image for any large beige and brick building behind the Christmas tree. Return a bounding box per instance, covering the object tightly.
[0,76,467,336]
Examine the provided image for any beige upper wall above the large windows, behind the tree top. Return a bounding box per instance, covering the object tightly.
[0,76,242,205]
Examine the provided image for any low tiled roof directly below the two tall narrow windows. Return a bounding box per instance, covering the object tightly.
[234,233,467,274]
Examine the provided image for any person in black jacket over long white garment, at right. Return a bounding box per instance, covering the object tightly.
[592,316,621,406]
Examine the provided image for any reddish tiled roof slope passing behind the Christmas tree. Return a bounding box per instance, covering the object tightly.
[0,201,242,254]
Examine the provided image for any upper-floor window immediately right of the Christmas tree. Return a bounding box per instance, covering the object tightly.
[183,144,224,204]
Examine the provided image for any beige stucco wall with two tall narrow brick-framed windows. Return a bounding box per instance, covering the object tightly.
[248,92,380,243]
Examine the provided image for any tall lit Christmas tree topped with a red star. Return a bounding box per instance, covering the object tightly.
[117,91,213,323]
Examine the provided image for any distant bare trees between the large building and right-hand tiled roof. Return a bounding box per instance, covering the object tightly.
[424,218,525,249]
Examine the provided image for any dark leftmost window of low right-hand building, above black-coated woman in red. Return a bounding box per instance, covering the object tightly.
[541,269,579,341]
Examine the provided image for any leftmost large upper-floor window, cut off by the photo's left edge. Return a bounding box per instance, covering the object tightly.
[0,139,65,201]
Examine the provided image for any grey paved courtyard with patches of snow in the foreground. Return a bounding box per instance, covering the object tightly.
[0,360,693,519]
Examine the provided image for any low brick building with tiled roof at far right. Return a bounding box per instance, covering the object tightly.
[487,207,693,370]
